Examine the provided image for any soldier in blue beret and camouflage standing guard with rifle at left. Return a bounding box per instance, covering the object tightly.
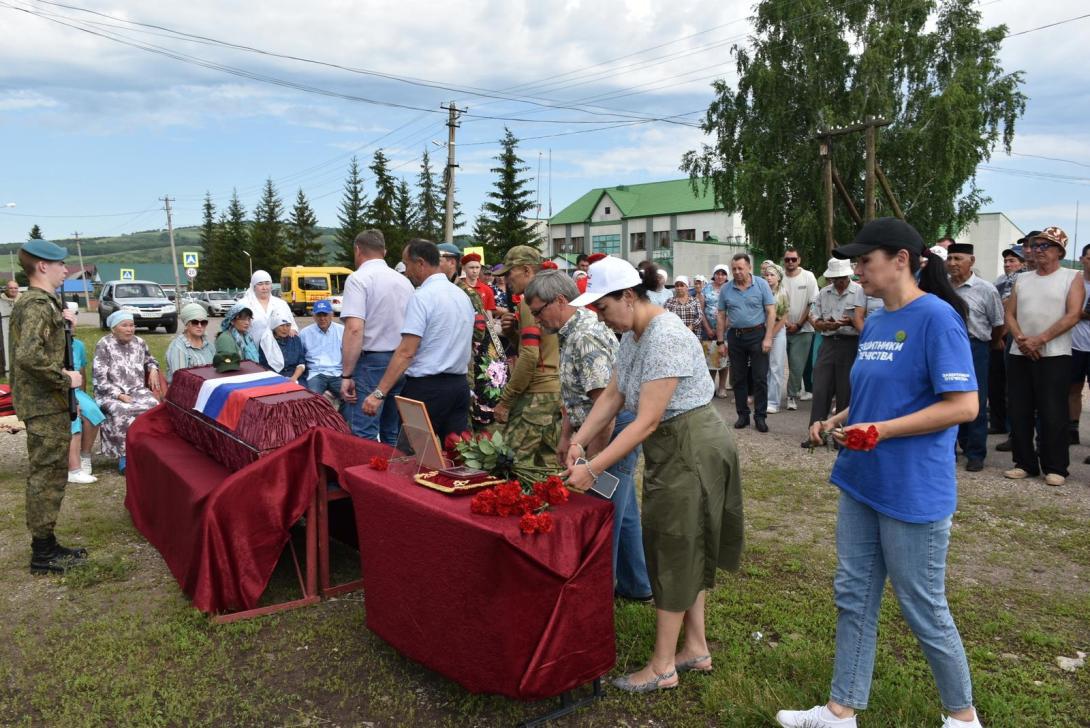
[11,240,87,574]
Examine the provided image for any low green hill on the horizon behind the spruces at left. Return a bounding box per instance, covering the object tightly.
[0,227,337,264]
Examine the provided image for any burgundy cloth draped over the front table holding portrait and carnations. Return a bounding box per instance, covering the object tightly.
[341,465,616,700]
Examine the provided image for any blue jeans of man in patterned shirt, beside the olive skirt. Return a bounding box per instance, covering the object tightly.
[606,410,651,598]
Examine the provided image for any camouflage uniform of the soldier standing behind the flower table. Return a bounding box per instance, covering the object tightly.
[499,300,560,468]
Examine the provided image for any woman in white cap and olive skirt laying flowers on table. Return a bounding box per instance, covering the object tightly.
[565,257,742,692]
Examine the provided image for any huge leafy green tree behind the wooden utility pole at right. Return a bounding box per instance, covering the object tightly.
[681,0,1026,262]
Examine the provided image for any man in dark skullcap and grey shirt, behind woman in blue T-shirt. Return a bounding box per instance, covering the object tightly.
[946,243,1003,472]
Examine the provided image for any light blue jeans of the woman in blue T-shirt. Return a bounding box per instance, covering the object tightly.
[829,493,972,712]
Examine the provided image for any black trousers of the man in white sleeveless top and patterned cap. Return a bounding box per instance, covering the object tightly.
[1007,355,1071,477]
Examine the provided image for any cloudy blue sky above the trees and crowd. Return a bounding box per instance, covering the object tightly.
[0,0,1090,251]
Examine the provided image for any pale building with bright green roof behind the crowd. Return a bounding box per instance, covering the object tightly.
[546,178,746,274]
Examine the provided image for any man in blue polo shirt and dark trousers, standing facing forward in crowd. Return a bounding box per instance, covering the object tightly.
[715,253,776,433]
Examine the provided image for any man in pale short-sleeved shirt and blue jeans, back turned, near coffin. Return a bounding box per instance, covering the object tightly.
[340,230,413,445]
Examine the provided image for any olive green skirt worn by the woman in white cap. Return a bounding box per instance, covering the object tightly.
[641,404,743,611]
